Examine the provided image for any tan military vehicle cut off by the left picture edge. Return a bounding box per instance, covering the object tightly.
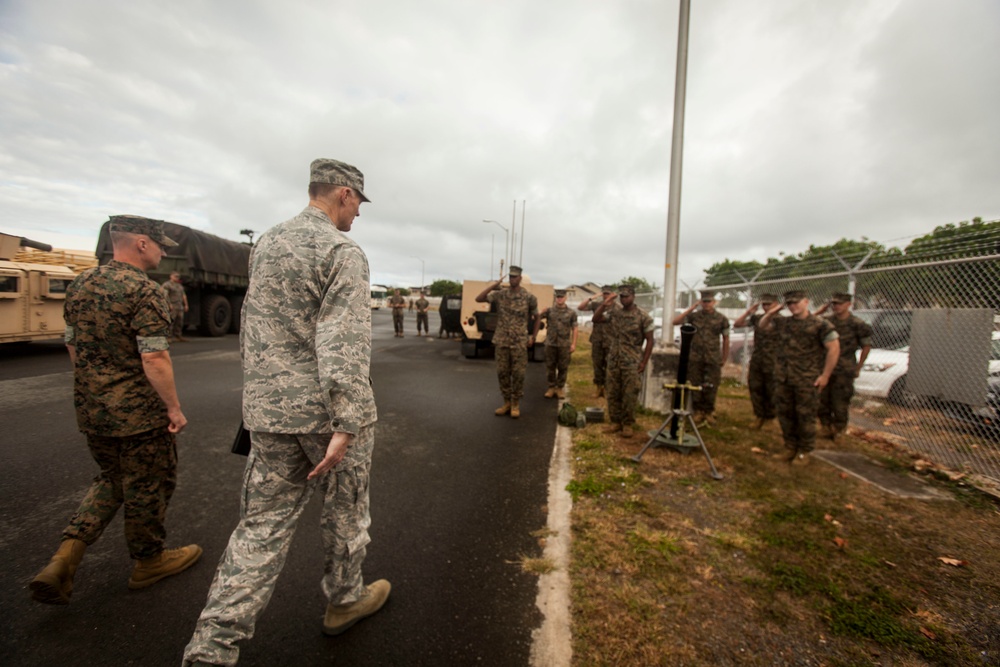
[0,233,97,343]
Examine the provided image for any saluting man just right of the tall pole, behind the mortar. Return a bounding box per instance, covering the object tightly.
[674,290,729,426]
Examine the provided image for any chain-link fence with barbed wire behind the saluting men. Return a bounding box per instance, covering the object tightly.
[704,239,1000,482]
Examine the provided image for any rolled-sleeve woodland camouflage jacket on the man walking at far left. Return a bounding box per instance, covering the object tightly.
[63,260,170,437]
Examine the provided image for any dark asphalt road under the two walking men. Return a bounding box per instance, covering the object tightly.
[0,311,556,667]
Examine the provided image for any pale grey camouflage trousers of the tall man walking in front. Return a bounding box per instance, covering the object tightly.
[184,425,375,665]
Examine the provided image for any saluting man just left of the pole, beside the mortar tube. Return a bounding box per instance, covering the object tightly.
[594,285,655,438]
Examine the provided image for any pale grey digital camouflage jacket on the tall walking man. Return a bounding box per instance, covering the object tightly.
[240,206,377,452]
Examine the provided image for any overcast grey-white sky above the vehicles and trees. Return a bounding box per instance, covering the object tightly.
[0,0,1000,287]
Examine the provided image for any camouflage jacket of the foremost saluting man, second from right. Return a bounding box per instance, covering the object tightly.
[771,315,837,385]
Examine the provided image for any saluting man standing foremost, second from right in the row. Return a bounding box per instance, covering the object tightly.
[760,290,840,463]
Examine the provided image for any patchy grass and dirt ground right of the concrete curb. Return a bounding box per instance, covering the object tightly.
[568,342,1000,667]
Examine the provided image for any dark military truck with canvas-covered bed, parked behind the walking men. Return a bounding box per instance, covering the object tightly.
[96,220,250,336]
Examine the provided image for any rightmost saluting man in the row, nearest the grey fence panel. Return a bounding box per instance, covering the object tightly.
[816,292,872,440]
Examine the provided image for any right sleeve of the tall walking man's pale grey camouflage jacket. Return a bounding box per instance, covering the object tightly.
[316,245,374,435]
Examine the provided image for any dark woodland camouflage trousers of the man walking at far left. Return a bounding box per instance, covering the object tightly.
[63,427,177,560]
